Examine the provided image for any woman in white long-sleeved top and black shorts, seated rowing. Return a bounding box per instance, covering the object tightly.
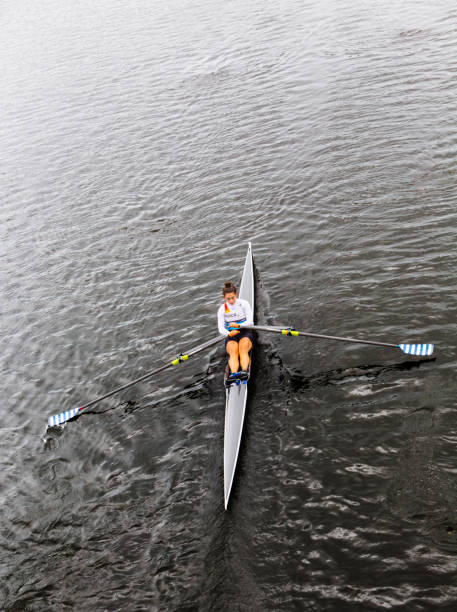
[217,282,254,383]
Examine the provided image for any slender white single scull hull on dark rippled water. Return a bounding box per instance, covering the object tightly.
[224,243,255,510]
